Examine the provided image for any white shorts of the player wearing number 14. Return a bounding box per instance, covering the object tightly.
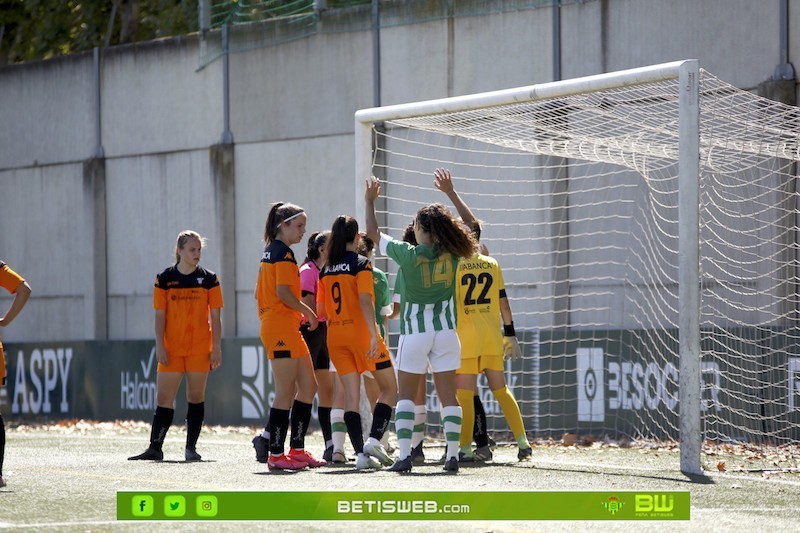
[397,329,461,374]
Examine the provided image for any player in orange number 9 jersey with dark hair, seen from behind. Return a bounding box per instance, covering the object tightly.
[317,215,397,470]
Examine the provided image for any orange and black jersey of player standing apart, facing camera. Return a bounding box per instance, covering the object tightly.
[153,265,222,356]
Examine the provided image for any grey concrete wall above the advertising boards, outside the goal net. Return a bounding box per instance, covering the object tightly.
[0,0,800,342]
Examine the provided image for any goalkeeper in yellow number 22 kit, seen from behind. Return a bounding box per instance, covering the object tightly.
[434,169,532,462]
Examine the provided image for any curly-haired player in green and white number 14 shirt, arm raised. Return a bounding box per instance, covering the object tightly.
[364,177,477,472]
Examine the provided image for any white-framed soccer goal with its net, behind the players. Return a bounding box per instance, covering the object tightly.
[355,60,800,474]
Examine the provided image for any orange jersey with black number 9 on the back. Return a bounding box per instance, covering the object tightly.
[317,252,375,346]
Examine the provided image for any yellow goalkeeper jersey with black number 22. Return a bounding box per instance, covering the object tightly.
[456,254,506,359]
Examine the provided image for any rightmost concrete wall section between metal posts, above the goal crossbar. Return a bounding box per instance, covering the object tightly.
[561,0,780,89]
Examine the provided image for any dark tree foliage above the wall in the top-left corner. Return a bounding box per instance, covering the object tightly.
[0,0,198,65]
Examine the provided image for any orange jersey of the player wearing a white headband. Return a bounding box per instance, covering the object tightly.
[256,241,303,329]
